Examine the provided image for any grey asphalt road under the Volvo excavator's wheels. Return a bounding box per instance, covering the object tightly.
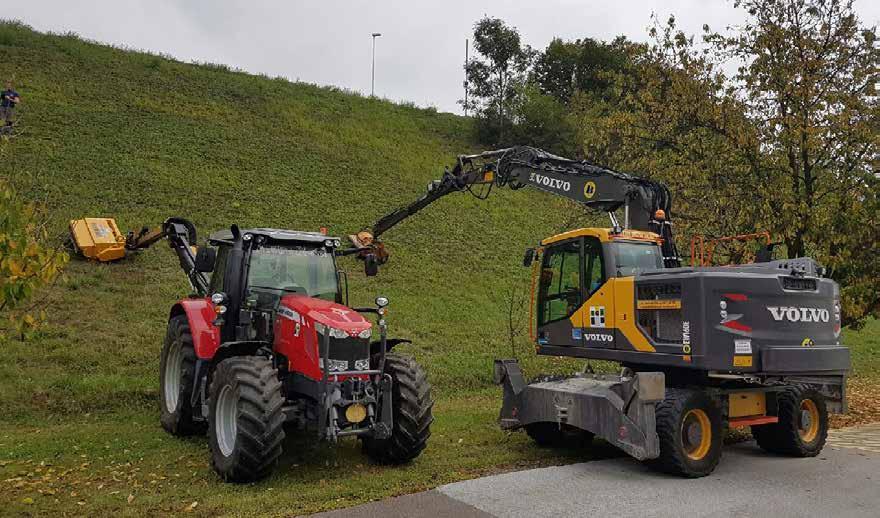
[317,442,880,518]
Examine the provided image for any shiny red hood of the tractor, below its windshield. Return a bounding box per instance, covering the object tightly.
[274,294,371,380]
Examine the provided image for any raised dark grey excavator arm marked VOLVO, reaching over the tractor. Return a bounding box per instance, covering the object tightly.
[350,146,680,267]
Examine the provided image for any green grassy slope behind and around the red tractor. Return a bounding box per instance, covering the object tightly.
[0,21,880,514]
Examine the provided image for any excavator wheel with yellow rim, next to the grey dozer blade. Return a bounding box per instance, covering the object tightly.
[650,389,724,478]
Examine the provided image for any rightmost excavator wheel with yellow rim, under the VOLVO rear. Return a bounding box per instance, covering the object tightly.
[752,386,828,457]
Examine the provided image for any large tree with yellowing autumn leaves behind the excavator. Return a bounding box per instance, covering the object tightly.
[579,0,880,324]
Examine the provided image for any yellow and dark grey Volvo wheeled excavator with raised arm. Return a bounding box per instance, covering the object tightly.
[350,147,850,477]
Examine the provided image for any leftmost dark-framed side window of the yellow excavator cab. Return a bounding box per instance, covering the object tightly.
[538,241,583,324]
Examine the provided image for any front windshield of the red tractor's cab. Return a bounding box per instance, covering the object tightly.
[248,246,339,301]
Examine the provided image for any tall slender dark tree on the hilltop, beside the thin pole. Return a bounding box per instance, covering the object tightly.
[461,17,533,144]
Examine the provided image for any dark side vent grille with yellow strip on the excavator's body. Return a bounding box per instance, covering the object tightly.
[636,283,682,344]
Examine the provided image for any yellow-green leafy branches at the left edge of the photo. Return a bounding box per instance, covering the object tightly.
[0,180,67,339]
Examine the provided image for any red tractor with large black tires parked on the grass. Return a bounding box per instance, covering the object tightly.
[119,218,433,482]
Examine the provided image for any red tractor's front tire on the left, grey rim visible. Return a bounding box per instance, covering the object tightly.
[208,356,284,482]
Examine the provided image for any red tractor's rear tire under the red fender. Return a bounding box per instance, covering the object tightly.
[159,315,206,436]
